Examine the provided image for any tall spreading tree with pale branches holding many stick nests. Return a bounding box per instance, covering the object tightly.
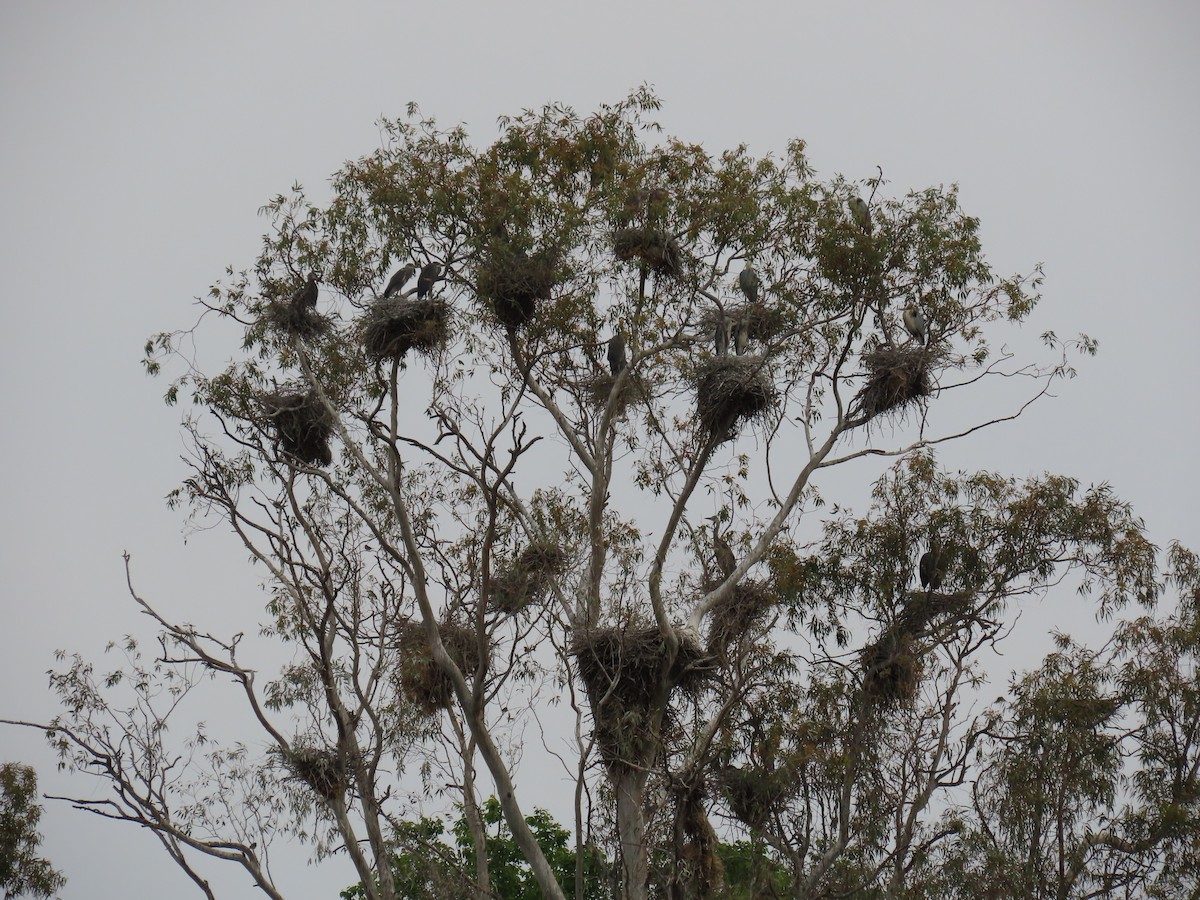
[2,89,1180,900]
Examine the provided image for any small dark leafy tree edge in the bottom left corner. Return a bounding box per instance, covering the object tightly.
[0,762,67,898]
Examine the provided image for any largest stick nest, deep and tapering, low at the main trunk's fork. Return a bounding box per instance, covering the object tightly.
[571,626,713,770]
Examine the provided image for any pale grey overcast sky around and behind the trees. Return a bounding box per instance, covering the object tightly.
[0,0,1200,900]
